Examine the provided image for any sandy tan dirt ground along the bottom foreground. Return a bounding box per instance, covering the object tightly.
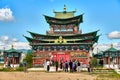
[0,72,96,80]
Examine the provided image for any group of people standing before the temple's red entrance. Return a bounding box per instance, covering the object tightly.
[44,60,91,72]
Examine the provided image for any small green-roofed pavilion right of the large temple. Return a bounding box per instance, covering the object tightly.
[95,44,120,69]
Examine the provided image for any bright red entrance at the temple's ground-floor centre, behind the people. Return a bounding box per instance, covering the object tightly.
[52,52,70,63]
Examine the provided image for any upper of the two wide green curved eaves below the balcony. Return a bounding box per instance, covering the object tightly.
[27,30,99,38]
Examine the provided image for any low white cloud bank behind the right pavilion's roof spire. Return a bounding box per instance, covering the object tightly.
[93,42,120,53]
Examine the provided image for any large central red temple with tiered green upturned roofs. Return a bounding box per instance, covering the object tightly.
[24,6,99,66]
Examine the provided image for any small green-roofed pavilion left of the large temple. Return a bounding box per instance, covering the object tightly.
[4,45,22,67]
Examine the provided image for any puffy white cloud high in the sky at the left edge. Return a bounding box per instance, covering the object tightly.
[0,8,14,21]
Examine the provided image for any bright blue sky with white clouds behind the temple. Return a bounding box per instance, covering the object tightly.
[0,0,120,49]
